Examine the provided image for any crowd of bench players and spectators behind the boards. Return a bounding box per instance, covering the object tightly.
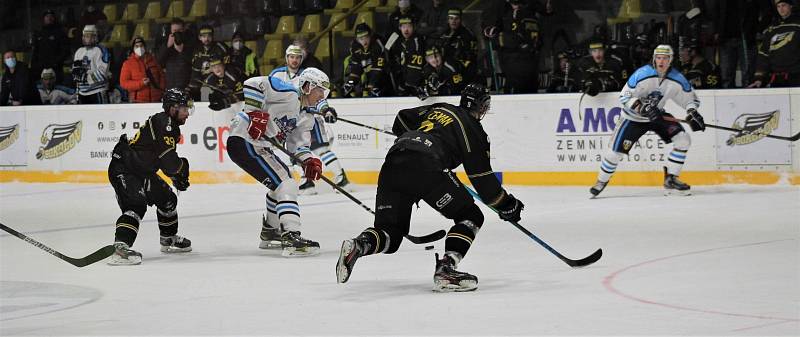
[0,0,800,109]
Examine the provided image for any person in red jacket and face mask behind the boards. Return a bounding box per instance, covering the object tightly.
[119,36,166,103]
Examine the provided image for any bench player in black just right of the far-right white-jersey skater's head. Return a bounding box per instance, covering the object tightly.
[677,38,721,89]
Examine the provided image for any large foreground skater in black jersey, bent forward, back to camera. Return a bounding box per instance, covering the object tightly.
[336,84,524,292]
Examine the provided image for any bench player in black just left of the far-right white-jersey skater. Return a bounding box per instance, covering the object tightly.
[577,39,623,96]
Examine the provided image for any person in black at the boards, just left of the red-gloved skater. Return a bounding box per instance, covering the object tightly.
[203,57,245,111]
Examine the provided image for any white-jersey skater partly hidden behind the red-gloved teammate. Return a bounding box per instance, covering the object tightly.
[270,45,350,195]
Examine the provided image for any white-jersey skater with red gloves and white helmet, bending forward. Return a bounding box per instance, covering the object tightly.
[227,68,330,257]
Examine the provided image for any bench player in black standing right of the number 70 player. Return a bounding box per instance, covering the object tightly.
[442,7,478,83]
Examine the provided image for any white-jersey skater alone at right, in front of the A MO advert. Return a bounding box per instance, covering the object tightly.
[589,45,705,197]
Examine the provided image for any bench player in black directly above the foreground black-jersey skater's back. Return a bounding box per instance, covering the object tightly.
[420,45,466,98]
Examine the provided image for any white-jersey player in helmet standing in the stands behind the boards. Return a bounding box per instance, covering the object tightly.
[72,25,111,104]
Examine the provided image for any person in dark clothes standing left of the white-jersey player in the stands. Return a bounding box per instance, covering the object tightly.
[31,9,70,83]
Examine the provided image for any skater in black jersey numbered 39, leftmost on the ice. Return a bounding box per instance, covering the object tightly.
[108,88,193,265]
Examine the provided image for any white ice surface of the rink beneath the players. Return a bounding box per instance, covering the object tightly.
[0,184,800,336]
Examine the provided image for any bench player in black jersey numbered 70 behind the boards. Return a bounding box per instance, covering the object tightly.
[387,16,425,97]
